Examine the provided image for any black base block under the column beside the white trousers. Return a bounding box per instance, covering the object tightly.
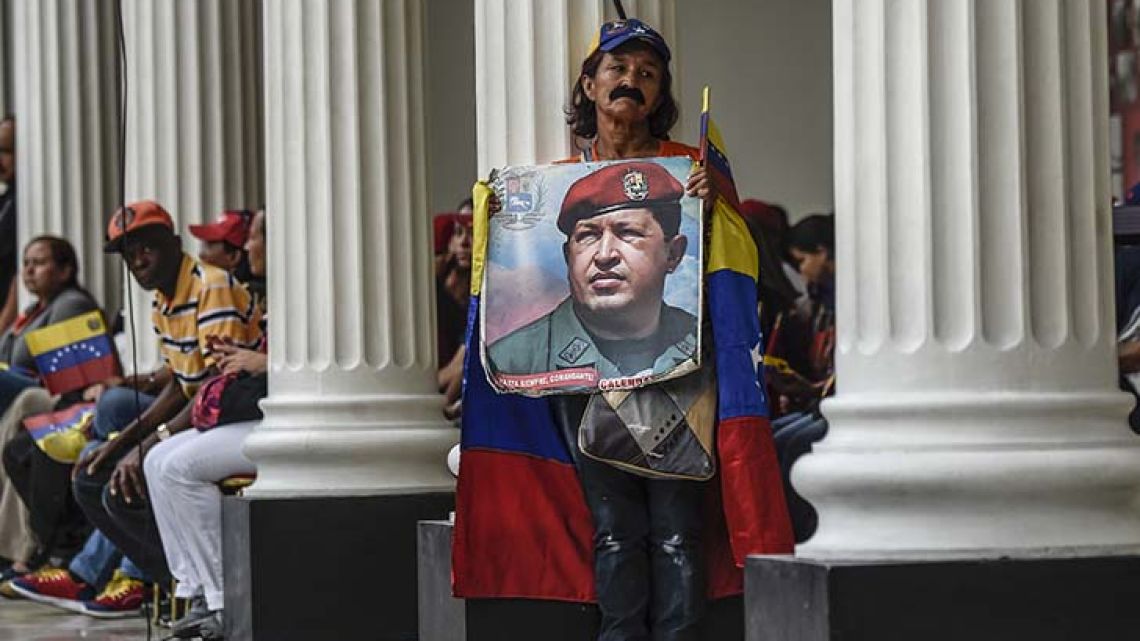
[222,493,455,641]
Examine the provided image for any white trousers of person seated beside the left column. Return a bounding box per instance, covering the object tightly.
[143,421,258,610]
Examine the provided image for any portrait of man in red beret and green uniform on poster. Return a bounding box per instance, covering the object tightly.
[487,161,699,391]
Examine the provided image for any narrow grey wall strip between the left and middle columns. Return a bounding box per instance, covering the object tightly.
[424,0,477,213]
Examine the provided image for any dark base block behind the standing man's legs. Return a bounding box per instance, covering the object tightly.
[420,521,744,641]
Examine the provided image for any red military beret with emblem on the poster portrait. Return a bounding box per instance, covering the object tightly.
[559,162,685,236]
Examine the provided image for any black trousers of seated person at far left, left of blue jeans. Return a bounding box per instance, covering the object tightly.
[3,431,90,557]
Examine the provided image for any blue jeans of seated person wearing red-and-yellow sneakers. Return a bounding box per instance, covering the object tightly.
[67,388,155,585]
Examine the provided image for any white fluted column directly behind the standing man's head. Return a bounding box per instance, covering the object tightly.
[475,0,681,172]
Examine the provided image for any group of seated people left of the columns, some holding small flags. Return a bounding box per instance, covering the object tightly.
[0,201,268,639]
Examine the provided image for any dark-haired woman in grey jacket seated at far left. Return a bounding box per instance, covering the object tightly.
[0,236,99,413]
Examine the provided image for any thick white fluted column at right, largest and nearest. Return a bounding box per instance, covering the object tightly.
[793,0,1140,559]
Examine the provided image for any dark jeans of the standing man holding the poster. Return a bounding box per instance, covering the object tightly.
[578,456,708,641]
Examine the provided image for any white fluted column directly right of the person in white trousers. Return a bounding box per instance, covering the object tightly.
[245,0,457,496]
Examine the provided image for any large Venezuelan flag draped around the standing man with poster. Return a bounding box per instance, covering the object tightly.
[453,149,793,602]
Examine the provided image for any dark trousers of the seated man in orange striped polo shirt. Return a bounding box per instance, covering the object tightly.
[72,444,171,583]
